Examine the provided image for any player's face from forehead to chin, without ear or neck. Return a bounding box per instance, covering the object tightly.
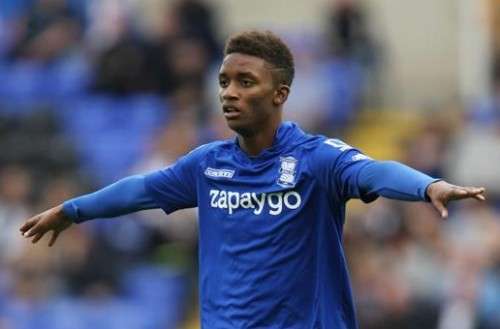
[219,53,280,135]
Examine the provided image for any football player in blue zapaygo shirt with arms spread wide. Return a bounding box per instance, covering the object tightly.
[20,31,485,329]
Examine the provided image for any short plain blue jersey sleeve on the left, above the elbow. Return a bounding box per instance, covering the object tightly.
[145,145,208,214]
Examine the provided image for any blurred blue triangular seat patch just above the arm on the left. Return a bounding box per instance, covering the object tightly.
[58,95,167,184]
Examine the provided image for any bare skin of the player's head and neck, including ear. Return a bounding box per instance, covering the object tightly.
[219,53,290,156]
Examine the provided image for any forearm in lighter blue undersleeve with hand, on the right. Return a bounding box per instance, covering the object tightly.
[358,161,485,218]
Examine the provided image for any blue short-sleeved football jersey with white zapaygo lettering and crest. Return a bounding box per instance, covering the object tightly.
[146,122,376,329]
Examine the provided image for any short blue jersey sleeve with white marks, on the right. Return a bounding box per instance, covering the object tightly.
[310,139,378,202]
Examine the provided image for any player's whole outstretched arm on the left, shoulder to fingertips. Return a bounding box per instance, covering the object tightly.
[20,144,207,246]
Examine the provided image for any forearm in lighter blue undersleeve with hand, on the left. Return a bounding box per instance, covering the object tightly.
[20,175,158,246]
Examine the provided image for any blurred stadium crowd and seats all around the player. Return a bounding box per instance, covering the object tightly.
[0,0,500,329]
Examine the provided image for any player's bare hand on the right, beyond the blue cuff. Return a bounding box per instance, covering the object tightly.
[427,181,486,219]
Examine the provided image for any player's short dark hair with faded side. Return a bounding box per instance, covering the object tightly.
[224,30,295,86]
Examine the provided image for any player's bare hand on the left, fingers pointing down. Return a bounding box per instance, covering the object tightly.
[19,205,73,247]
